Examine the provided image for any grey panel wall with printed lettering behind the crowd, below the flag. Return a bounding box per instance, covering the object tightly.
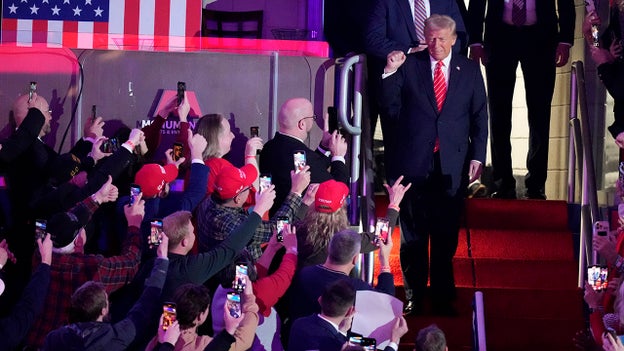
[0,50,333,163]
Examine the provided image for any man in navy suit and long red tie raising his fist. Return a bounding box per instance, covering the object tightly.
[380,15,487,315]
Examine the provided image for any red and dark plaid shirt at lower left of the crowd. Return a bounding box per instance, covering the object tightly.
[26,227,141,348]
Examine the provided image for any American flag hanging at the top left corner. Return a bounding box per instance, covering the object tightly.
[2,0,202,51]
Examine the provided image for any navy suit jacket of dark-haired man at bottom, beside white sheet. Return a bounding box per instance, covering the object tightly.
[288,314,347,351]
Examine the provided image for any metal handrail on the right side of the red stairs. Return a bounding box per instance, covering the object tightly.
[568,61,601,288]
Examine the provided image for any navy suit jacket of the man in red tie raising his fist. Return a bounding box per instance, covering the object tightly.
[380,50,488,195]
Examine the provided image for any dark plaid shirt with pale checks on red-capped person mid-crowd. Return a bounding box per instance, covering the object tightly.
[197,193,302,262]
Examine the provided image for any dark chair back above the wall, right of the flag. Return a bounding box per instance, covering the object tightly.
[201,9,263,39]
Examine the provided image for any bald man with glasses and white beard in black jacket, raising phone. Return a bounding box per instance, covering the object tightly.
[260,98,349,215]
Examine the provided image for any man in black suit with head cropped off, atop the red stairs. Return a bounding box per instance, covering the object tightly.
[468,0,576,199]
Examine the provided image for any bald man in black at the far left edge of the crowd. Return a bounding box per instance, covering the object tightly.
[0,93,103,313]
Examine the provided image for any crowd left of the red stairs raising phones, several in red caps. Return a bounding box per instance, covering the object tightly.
[0,81,428,351]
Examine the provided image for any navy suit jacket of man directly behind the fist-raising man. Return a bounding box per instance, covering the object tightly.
[366,0,468,60]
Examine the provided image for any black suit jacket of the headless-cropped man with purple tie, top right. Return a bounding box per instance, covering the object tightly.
[468,0,576,46]
